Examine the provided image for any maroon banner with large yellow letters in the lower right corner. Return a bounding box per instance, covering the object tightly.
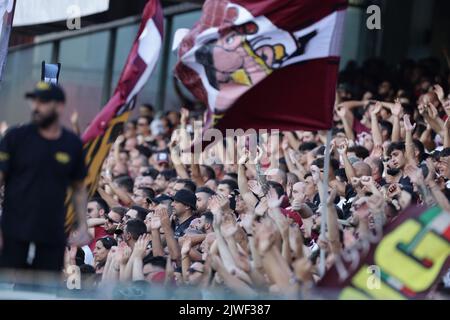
[319,207,450,299]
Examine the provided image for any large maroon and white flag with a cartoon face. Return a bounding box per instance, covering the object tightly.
[174,0,347,131]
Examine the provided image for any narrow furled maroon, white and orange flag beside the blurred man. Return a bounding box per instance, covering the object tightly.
[66,0,164,228]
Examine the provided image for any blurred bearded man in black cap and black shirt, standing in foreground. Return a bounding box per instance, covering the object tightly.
[0,82,90,271]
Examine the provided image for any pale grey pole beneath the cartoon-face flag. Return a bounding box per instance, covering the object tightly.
[319,129,332,277]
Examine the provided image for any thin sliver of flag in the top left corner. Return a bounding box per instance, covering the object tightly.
[0,0,15,81]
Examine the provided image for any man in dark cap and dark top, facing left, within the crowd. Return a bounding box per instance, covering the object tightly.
[171,189,197,238]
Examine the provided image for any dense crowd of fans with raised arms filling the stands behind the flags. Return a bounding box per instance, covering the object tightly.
[2,59,450,298]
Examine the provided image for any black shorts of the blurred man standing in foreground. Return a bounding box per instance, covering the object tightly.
[0,237,65,271]
